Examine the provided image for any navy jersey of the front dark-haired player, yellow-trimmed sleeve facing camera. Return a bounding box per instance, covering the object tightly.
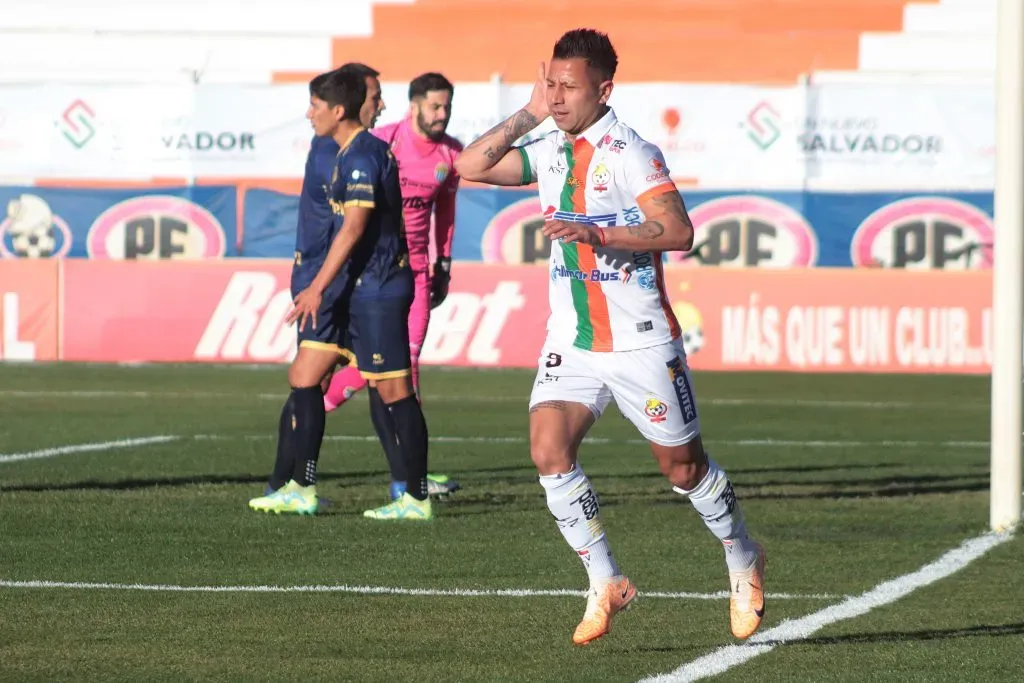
[330,129,413,297]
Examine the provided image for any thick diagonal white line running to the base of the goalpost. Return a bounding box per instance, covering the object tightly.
[640,532,1013,683]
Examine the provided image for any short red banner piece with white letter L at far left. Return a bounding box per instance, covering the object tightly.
[0,259,60,360]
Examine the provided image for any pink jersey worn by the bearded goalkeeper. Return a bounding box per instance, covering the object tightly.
[372,118,462,272]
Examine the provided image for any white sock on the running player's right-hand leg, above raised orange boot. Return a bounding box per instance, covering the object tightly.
[672,457,758,571]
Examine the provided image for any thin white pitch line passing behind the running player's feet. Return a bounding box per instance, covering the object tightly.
[0,580,844,600]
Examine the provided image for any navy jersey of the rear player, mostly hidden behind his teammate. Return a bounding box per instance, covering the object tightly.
[292,137,341,294]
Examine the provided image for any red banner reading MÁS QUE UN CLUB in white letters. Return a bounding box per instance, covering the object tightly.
[666,268,992,374]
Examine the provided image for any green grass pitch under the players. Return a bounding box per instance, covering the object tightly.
[0,365,1024,682]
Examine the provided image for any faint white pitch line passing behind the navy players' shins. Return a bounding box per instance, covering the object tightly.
[191,434,988,449]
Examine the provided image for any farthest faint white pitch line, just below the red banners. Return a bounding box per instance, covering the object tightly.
[0,389,989,411]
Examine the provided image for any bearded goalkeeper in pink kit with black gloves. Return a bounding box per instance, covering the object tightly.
[324,73,462,499]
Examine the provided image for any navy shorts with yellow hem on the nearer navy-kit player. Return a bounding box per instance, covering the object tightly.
[342,296,413,380]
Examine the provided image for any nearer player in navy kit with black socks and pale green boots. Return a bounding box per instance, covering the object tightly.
[249,70,433,519]
